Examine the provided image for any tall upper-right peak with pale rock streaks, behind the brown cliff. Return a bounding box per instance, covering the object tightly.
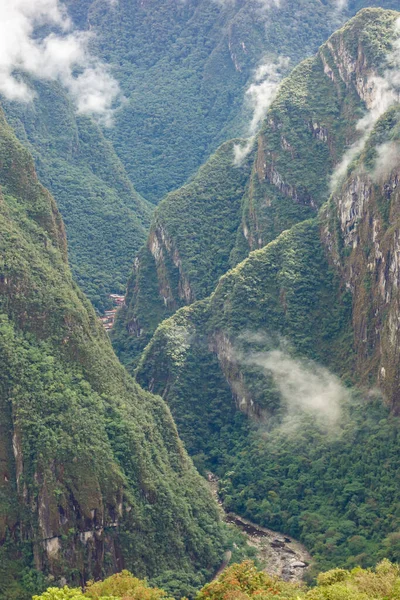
[238,9,395,250]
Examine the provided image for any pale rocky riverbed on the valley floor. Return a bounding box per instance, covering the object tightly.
[207,473,311,581]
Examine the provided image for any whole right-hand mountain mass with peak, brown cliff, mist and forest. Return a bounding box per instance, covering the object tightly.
[117,9,400,569]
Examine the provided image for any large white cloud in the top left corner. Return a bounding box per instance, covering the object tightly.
[0,0,119,123]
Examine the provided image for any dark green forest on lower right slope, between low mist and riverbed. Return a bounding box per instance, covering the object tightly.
[221,398,400,570]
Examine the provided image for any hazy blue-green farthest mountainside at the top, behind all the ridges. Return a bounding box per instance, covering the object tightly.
[66,0,397,201]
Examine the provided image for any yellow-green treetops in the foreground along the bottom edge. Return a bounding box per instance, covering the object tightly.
[33,560,400,600]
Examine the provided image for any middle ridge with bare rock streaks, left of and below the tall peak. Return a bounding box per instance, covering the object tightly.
[113,142,250,364]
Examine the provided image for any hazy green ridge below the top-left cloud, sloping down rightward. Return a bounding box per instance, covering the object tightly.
[3,81,151,311]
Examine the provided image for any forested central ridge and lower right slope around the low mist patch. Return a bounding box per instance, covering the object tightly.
[137,210,400,569]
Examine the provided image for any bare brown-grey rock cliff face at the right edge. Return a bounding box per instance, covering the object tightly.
[321,107,400,412]
